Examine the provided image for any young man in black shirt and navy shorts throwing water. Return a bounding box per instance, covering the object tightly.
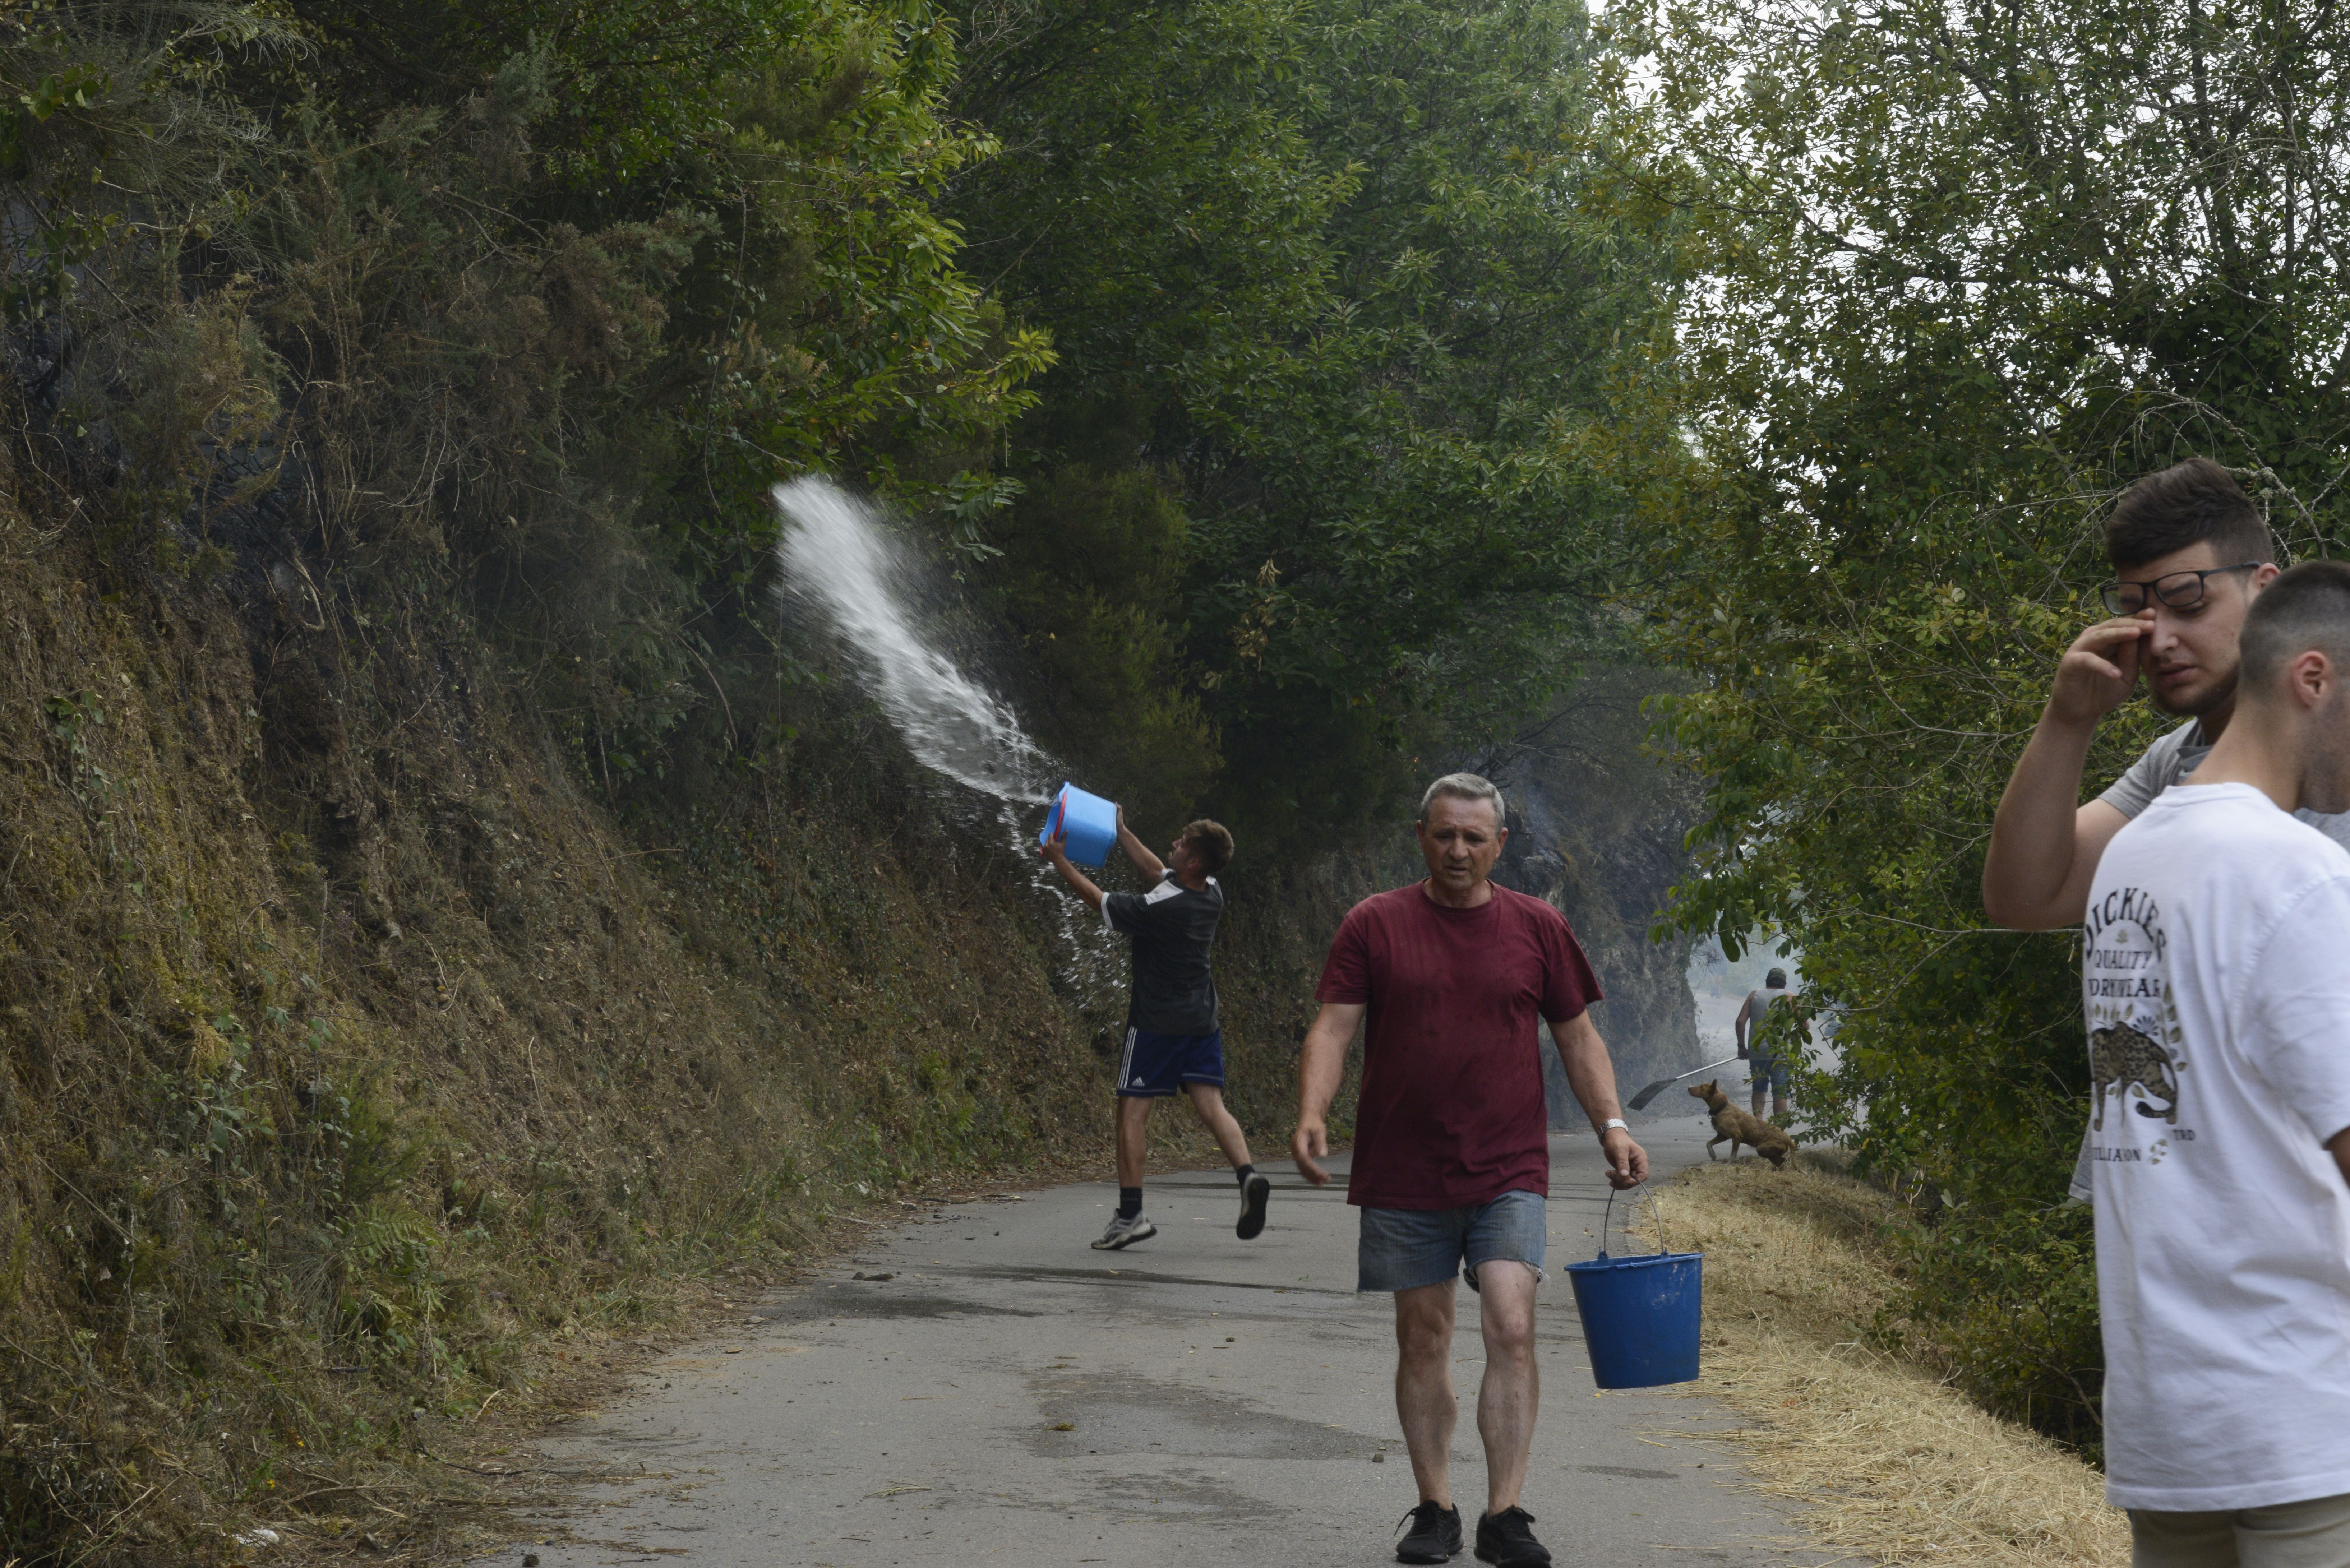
[1039,811,1274,1253]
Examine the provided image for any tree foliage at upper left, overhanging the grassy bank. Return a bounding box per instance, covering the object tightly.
[0,0,1051,790]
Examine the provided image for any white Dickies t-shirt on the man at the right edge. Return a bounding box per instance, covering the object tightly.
[2082,783,2350,1512]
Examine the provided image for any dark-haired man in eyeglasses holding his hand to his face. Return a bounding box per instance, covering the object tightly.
[1984,458,2350,931]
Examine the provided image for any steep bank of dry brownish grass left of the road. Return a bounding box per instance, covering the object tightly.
[0,430,1382,1563]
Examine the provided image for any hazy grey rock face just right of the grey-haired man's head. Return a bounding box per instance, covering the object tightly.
[1485,670,1704,1128]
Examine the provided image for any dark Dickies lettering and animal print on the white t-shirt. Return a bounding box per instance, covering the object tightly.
[2082,889,2185,1159]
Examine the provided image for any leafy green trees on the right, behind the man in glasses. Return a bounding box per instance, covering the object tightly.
[1603,0,2350,1443]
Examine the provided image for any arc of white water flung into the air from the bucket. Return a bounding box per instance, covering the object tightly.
[773,475,1053,804]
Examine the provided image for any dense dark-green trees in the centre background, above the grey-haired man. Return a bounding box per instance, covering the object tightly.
[952,0,1654,839]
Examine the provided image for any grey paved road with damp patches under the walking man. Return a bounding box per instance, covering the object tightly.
[479,1119,1824,1568]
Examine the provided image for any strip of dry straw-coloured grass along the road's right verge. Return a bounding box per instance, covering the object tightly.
[1661,1159,2129,1568]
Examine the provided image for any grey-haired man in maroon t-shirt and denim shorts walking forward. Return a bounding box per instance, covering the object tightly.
[1290,773,1647,1568]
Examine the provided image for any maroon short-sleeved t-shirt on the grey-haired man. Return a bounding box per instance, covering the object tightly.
[1313,882,1600,1208]
